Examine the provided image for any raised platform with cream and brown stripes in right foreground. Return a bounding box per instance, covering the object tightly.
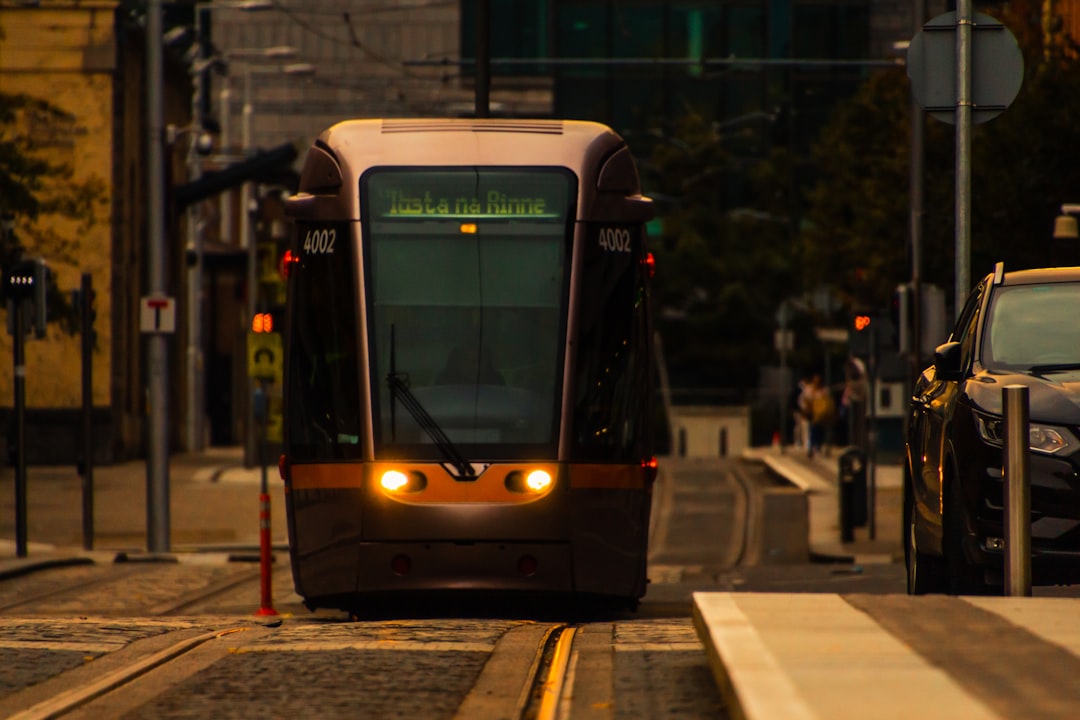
[693,593,1080,720]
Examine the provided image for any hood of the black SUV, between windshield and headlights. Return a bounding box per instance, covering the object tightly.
[964,370,1080,425]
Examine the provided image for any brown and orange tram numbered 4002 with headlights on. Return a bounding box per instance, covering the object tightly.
[281,119,656,611]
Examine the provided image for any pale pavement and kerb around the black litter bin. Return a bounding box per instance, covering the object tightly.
[743,447,904,565]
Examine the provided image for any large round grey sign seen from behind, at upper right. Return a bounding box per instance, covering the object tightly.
[907,12,1024,123]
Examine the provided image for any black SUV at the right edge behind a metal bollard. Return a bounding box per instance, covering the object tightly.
[904,263,1080,595]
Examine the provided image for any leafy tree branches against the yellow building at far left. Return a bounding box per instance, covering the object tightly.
[0,93,107,332]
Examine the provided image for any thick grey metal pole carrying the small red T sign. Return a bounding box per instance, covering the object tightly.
[146,0,170,553]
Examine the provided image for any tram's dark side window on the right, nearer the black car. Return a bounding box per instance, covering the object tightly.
[573,226,649,461]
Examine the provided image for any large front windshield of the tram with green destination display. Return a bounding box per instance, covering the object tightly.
[361,167,577,460]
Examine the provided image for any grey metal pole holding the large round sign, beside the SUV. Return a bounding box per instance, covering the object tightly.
[954,0,974,312]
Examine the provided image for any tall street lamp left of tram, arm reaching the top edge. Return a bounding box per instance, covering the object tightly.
[185,0,274,452]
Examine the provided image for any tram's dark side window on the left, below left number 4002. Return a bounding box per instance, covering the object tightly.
[286,222,360,460]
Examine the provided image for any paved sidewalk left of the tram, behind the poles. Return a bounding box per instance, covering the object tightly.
[0,447,287,567]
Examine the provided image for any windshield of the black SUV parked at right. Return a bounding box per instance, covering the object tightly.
[982,283,1080,371]
